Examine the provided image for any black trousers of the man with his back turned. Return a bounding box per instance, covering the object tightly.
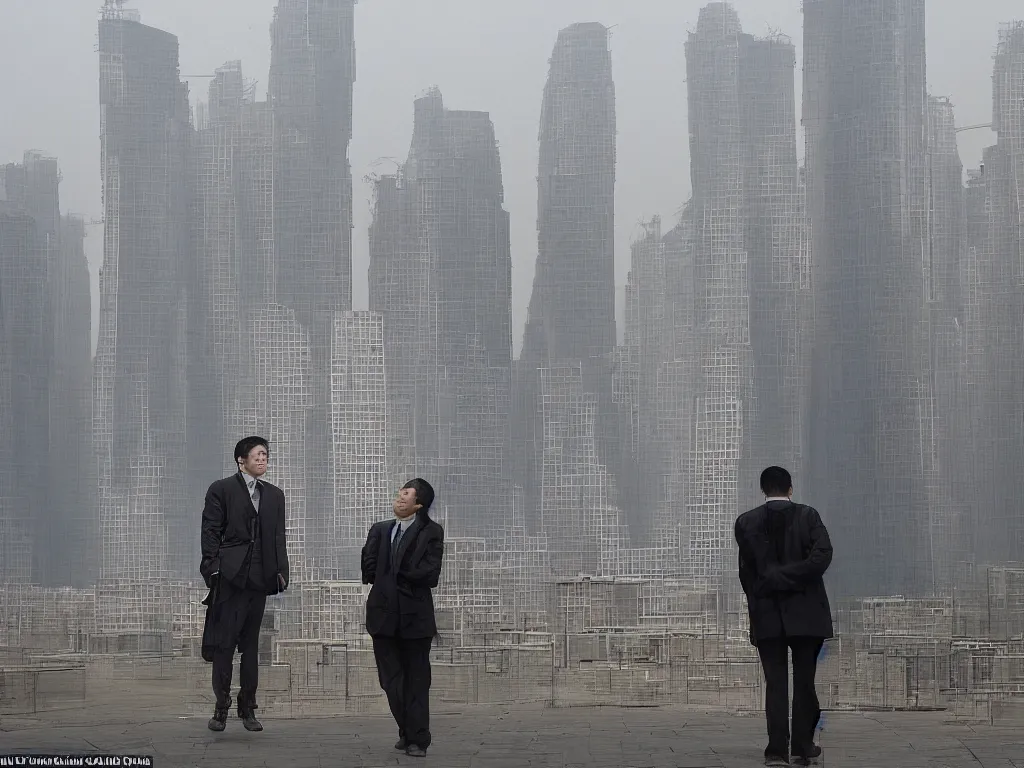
[758,637,824,758]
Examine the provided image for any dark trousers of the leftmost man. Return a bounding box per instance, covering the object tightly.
[213,588,266,710]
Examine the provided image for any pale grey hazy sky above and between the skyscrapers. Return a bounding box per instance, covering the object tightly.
[0,0,1007,349]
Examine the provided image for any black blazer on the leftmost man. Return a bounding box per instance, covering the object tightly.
[199,472,288,595]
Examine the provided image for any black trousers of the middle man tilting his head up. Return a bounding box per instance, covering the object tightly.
[374,636,433,750]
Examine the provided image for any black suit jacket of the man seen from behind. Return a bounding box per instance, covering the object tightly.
[735,502,833,645]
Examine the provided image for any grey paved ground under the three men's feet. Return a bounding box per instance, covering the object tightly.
[0,696,1024,768]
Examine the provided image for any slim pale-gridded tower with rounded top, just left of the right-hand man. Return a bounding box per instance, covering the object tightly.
[684,3,755,580]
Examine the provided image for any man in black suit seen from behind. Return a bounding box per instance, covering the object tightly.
[735,467,833,766]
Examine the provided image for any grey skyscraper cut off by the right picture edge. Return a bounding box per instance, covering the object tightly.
[965,22,1024,562]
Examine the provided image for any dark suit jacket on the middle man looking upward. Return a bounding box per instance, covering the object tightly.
[361,512,444,639]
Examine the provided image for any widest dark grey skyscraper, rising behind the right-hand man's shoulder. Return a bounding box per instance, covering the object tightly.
[804,0,945,594]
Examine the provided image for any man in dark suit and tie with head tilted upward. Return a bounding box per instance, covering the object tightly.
[361,477,444,757]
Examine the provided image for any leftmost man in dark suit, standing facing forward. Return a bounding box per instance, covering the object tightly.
[200,436,288,731]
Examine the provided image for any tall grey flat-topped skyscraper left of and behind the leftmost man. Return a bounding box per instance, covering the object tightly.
[93,9,192,631]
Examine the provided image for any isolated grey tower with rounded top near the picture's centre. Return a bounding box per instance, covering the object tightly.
[513,24,621,526]
